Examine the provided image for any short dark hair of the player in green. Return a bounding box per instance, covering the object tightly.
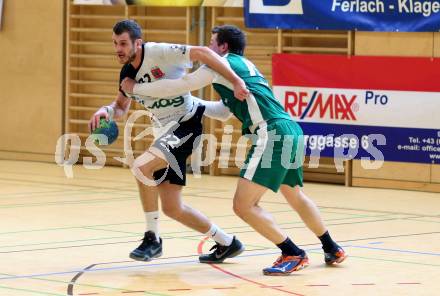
[211,25,246,55]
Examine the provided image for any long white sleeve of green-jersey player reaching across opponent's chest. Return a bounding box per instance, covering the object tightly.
[133,66,216,98]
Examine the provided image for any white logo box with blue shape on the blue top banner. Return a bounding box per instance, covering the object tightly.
[249,0,303,14]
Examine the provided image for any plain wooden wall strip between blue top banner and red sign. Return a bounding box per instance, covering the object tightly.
[354,32,433,57]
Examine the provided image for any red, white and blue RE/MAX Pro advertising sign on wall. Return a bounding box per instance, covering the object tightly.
[272,54,440,163]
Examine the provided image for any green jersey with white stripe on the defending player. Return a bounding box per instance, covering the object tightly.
[213,53,291,133]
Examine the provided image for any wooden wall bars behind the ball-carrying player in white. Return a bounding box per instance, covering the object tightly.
[66,0,197,165]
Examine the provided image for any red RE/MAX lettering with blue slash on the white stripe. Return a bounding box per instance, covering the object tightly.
[284,90,359,121]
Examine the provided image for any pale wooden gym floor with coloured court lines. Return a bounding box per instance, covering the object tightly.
[0,161,440,296]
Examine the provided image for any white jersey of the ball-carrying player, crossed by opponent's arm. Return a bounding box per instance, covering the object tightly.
[120,42,195,126]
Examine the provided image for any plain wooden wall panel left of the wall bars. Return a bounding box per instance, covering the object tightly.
[0,0,64,160]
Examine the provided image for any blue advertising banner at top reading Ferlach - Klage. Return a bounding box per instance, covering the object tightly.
[244,0,440,32]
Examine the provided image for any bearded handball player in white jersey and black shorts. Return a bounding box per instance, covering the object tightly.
[89,20,248,263]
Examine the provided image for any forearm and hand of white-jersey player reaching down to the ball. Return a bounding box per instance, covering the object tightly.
[89,92,131,132]
